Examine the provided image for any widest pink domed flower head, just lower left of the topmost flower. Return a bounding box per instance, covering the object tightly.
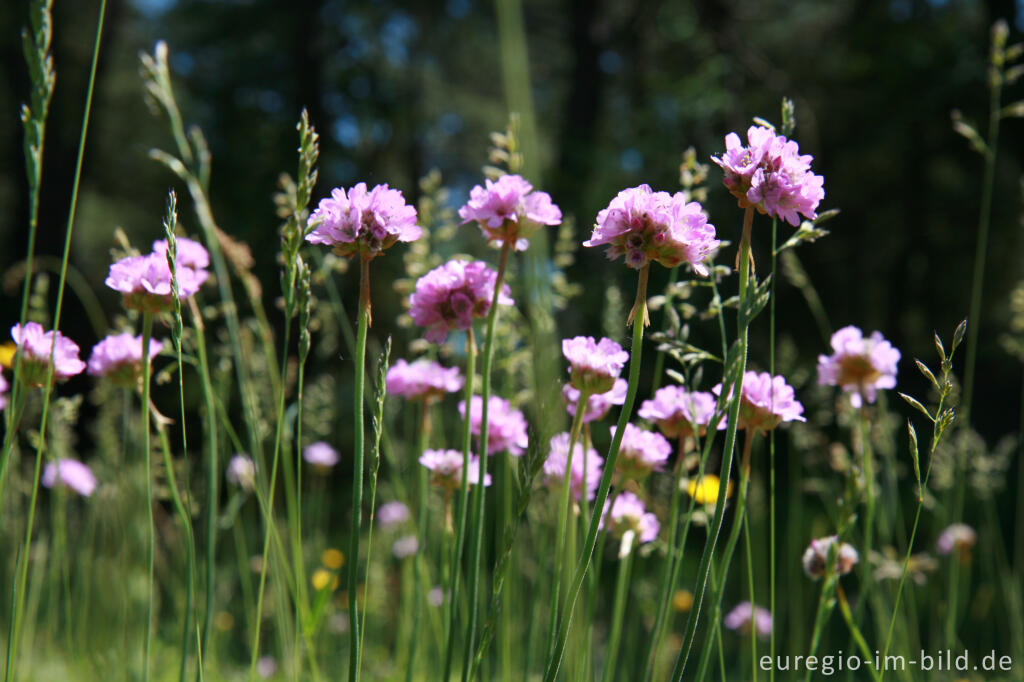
[583,184,720,276]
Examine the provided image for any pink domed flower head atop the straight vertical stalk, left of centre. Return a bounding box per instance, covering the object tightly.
[306,182,423,260]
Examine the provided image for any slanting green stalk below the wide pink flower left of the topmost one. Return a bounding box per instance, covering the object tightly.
[544,264,650,682]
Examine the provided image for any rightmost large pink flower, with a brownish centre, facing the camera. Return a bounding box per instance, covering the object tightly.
[818,325,900,408]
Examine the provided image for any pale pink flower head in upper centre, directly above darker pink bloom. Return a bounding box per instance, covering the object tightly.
[459,175,562,251]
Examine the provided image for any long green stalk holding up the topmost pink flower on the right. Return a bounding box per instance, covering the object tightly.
[672,208,754,680]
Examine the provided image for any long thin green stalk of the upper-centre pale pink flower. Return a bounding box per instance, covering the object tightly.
[462,239,513,682]
